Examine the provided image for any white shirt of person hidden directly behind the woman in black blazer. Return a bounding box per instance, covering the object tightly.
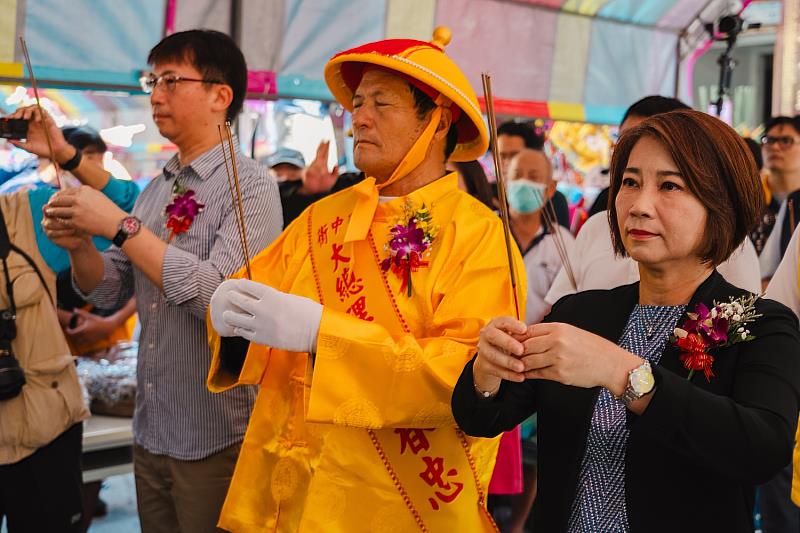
[545,211,761,305]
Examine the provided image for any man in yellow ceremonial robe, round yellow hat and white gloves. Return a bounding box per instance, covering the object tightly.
[208,28,526,533]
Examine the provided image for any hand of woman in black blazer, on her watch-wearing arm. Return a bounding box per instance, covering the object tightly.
[520,322,642,396]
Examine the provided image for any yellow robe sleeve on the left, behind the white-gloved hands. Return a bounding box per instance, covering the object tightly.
[206,210,309,392]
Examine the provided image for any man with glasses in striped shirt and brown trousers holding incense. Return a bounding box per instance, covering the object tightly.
[43,30,282,533]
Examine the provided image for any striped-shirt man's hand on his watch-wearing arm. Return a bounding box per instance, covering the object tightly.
[42,185,127,239]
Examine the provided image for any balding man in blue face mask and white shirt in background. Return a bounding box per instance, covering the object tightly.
[508,148,575,324]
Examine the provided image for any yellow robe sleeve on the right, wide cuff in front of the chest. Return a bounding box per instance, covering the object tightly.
[306,217,526,429]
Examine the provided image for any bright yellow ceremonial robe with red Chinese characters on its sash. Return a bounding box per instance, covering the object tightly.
[208,174,526,533]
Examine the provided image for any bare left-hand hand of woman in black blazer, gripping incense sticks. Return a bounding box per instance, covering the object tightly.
[472,316,527,394]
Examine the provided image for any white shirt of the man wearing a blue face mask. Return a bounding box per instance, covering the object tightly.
[522,225,575,324]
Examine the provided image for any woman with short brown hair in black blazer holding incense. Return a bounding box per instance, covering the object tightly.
[453,111,800,533]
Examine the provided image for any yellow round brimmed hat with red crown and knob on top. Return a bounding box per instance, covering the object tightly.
[325,26,489,161]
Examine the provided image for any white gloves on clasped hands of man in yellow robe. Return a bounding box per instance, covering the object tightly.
[211,279,322,352]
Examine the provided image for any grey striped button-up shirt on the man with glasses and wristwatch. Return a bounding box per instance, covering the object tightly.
[84,142,283,460]
